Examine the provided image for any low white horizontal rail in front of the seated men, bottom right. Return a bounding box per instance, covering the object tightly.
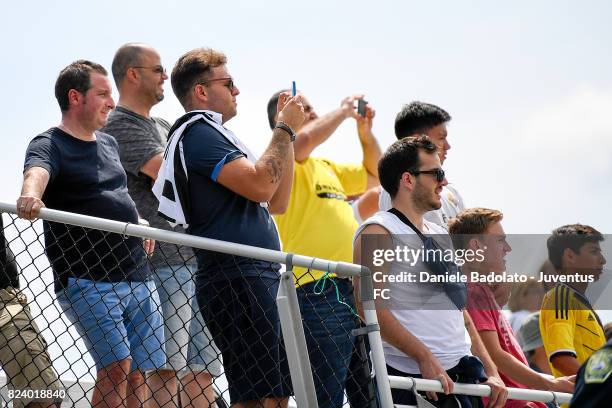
[389,376,572,404]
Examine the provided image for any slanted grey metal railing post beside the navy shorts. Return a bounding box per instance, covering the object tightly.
[276,254,319,408]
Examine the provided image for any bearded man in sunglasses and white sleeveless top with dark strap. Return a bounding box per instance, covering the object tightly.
[353,136,507,407]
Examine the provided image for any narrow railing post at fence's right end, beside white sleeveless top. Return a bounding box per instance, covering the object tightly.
[359,267,393,408]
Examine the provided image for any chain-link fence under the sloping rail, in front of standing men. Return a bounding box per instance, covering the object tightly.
[0,204,388,408]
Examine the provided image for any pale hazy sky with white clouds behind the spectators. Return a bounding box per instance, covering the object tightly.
[0,0,612,378]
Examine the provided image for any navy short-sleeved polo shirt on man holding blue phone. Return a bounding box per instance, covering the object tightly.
[183,121,280,282]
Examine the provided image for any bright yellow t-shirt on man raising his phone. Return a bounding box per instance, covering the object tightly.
[274,158,367,286]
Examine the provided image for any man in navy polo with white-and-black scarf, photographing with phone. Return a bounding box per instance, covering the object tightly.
[163,49,304,407]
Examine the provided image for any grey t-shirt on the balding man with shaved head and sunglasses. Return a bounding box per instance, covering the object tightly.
[102,106,195,268]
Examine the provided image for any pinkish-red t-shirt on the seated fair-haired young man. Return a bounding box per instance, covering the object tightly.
[467,283,546,408]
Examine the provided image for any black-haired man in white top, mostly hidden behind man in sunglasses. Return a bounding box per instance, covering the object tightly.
[378,101,465,230]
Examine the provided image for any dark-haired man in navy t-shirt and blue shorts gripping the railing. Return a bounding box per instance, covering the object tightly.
[17,60,166,407]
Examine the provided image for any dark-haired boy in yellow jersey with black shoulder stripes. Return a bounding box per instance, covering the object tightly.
[540,224,606,377]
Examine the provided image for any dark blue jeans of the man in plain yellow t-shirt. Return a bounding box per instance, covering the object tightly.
[297,278,356,408]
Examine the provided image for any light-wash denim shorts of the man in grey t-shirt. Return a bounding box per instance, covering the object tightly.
[153,265,223,377]
